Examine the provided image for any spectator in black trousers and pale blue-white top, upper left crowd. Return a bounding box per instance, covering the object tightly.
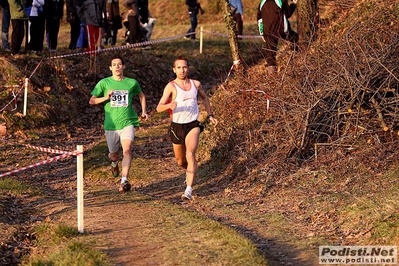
[28,0,45,53]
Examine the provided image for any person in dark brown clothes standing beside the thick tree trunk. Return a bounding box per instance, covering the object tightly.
[257,0,298,74]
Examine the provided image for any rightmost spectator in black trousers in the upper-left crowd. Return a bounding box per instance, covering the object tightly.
[124,0,144,44]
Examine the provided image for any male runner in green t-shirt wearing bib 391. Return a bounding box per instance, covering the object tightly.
[89,56,148,192]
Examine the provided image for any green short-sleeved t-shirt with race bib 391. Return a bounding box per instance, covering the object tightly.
[91,77,141,130]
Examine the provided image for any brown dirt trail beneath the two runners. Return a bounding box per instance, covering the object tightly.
[0,115,315,266]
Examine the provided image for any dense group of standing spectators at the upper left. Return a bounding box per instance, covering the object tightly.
[0,0,155,56]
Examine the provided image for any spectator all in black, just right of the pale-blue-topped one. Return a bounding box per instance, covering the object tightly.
[44,0,64,51]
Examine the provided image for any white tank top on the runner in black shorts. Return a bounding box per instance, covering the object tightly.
[173,79,199,124]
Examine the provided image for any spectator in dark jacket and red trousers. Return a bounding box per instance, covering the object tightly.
[78,0,107,52]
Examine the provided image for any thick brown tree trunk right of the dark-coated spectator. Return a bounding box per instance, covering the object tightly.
[297,0,320,45]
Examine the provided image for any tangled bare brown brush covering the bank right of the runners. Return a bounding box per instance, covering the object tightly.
[208,1,399,187]
